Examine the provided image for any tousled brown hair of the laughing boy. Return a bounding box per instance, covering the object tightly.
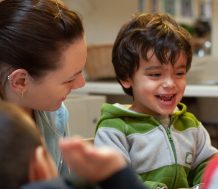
[112,13,192,96]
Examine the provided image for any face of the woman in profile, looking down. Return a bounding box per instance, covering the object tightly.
[23,38,87,111]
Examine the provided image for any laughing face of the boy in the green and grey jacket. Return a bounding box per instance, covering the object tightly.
[124,51,186,116]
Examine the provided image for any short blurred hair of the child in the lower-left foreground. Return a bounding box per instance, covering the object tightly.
[0,101,43,189]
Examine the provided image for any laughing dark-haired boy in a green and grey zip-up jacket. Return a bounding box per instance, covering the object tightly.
[95,13,217,189]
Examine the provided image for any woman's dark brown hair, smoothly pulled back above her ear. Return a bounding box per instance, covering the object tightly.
[0,0,84,96]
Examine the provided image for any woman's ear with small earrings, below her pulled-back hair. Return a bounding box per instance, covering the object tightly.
[8,69,28,95]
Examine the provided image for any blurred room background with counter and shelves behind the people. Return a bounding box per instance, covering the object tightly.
[64,0,218,147]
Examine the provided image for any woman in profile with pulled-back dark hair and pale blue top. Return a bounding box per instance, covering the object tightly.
[0,0,87,174]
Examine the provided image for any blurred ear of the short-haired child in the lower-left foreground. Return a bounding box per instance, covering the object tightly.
[29,146,57,182]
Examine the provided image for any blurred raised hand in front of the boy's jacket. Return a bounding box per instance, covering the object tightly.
[59,138,126,182]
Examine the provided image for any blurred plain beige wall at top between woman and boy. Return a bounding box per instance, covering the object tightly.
[64,0,138,44]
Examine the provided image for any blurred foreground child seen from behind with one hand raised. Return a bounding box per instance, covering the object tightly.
[0,101,145,189]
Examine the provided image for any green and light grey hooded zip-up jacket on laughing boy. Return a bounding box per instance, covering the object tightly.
[95,103,217,189]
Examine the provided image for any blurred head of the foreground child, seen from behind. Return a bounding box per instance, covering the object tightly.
[0,101,57,189]
